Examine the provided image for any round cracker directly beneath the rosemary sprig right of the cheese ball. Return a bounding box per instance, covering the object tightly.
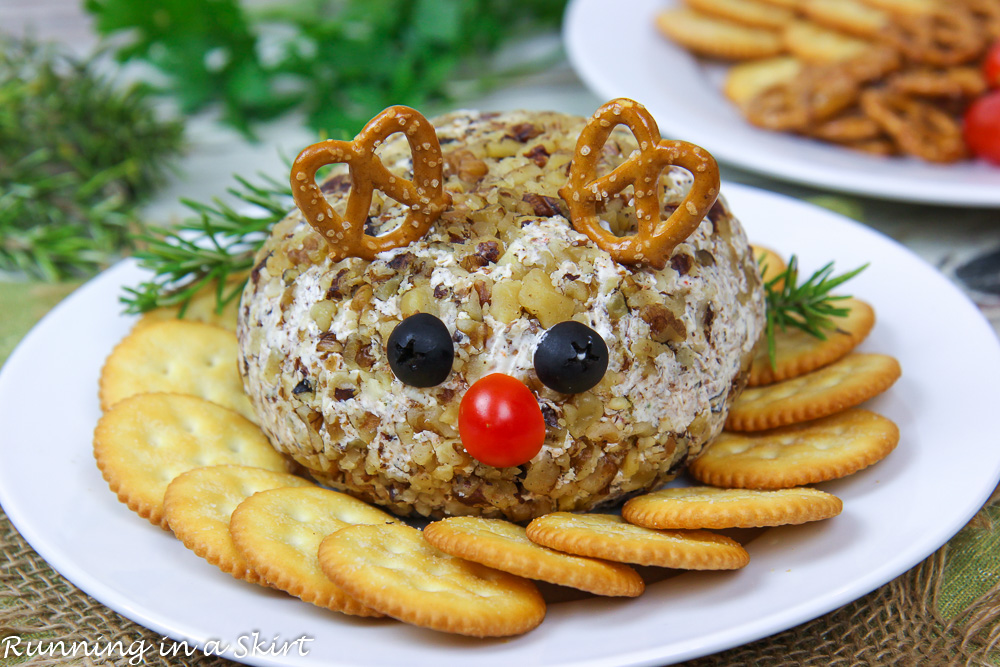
[747,298,875,387]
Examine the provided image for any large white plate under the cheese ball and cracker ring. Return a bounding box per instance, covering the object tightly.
[0,184,1000,667]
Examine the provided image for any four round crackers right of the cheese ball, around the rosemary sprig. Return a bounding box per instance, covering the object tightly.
[689,245,901,489]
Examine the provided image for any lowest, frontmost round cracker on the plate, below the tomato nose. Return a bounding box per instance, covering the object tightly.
[319,524,545,637]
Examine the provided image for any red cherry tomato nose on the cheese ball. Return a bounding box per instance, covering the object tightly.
[458,373,545,468]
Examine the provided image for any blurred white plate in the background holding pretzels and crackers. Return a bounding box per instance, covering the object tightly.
[563,0,1000,207]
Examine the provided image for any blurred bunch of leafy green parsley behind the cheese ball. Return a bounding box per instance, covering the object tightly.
[84,0,566,136]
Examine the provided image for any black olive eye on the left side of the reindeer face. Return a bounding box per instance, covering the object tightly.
[386,313,455,387]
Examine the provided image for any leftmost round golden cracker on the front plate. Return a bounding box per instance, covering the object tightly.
[94,394,290,528]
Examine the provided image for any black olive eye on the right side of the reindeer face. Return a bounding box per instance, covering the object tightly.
[534,320,608,394]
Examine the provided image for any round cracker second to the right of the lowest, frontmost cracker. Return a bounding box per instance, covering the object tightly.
[526,512,750,570]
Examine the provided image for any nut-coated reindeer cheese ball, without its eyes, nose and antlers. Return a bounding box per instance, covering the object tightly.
[238,111,764,521]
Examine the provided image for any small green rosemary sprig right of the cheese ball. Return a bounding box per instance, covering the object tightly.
[764,255,868,368]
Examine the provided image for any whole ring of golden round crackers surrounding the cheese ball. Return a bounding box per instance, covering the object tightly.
[94,254,899,637]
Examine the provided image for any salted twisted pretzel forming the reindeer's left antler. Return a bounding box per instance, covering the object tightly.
[291,106,451,261]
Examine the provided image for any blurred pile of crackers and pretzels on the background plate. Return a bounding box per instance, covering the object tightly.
[656,0,1000,163]
